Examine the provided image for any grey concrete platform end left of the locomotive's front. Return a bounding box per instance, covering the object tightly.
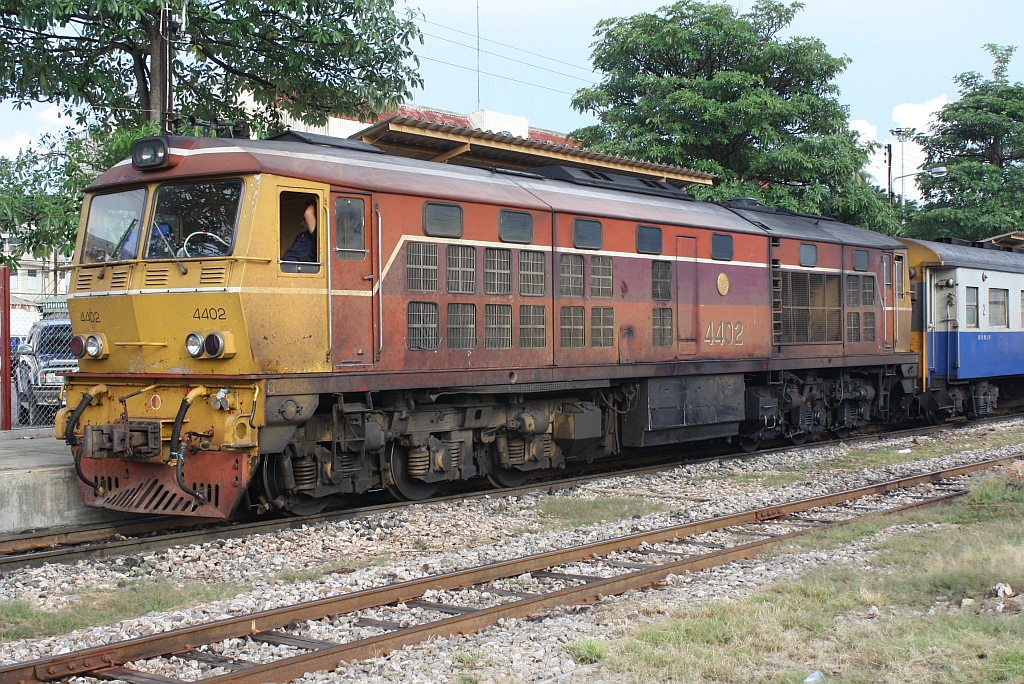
[0,428,136,537]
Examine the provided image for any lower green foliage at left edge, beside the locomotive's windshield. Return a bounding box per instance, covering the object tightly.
[0,123,159,267]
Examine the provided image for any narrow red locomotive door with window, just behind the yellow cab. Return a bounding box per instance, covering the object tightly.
[330,193,378,371]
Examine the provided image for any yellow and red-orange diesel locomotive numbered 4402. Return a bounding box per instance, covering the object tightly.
[56,137,999,518]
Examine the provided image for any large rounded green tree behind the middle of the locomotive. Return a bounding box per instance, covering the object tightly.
[571,0,898,231]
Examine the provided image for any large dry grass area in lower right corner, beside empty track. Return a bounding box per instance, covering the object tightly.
[598,477,1024,684]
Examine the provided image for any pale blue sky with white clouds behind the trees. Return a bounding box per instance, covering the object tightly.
[0,0,1024,198]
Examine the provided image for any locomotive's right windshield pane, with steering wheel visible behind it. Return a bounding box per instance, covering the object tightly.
[145,178,244,259]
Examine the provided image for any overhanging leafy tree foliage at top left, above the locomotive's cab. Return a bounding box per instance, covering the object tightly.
[0,0,422,126]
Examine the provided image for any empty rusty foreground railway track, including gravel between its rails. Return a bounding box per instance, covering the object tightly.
[0,457,1016,684]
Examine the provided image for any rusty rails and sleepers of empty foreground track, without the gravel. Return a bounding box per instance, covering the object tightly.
[0,457,1016,684]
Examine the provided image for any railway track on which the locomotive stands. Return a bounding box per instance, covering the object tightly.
[0,415,1018,572]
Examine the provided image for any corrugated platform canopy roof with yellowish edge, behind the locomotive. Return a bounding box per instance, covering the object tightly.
[350,106,715,187]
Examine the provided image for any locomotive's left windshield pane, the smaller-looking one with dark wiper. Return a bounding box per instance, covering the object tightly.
[82,187,145,263]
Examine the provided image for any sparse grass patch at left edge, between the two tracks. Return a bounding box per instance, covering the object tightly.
[0,580,245,642]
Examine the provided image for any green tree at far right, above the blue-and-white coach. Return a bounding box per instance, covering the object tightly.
[911,44,1024,240]
